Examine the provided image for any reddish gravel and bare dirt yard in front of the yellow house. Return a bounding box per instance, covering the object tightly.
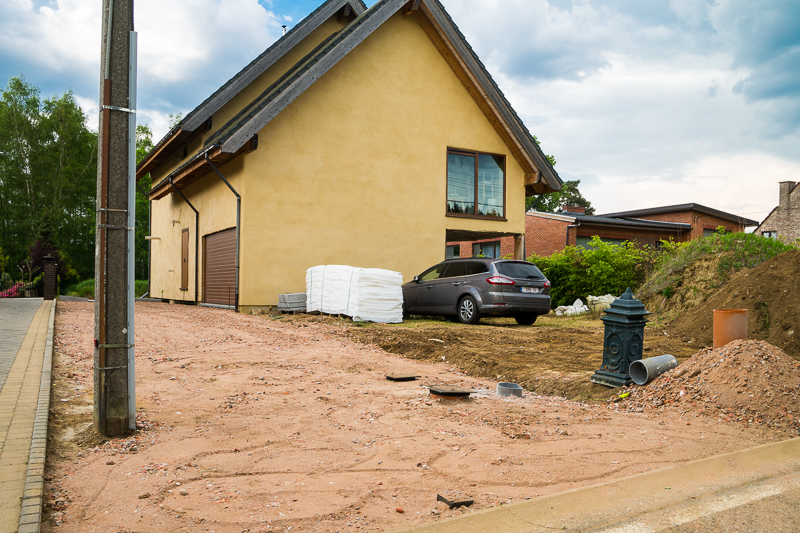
[43,302,793,533]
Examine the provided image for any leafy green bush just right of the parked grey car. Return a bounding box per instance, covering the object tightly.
[528,237,658,307]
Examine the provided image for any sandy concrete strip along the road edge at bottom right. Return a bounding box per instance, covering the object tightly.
[395,438,800,533]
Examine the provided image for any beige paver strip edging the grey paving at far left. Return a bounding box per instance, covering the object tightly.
[19,300,56,533]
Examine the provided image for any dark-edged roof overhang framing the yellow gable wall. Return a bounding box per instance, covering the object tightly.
[150,0,562,199]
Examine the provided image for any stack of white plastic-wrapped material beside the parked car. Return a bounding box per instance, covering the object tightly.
[306,265,403,324]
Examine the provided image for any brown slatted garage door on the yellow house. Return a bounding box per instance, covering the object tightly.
[203,228,236,306]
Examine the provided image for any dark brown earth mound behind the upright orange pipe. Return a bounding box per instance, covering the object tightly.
[660,250,800,359]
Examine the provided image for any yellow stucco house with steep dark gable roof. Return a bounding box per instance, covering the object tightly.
[137,0,561,311]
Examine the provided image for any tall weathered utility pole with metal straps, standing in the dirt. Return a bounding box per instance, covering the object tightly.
[94,0,136,437]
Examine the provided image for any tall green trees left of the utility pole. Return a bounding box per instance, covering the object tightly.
[0,76,97,277]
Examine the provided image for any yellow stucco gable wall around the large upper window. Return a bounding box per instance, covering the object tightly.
[241,13,525,306]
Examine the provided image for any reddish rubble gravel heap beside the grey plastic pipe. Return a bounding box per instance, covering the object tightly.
[626,340,800,434]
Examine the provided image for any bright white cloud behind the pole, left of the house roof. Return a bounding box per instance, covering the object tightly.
[0,0,281,122]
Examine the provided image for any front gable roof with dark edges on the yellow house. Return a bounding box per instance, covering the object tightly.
[151,0,562,198]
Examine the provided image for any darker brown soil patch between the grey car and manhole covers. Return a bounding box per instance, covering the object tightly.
[338,315,704,402]
